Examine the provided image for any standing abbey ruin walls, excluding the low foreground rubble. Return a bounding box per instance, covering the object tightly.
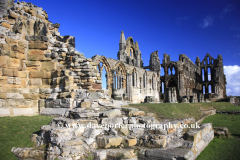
[0,0,226,116]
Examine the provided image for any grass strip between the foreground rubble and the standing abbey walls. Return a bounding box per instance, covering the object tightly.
[130,102,233,119]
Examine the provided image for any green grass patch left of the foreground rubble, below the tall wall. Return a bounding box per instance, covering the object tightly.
[0,115,53,160]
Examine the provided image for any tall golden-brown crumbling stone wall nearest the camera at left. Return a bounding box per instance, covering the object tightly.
[0,2,88,116]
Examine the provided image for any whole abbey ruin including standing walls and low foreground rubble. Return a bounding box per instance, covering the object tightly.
[0,0,226,160]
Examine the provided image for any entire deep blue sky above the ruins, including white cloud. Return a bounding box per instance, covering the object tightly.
[22,0,240,96]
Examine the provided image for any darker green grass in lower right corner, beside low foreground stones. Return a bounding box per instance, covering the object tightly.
[197,114,240,160]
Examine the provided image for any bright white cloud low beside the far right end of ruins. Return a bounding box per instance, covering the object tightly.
[223,65,240,96]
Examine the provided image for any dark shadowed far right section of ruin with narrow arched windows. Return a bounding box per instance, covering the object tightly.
[160,53,226,103]
